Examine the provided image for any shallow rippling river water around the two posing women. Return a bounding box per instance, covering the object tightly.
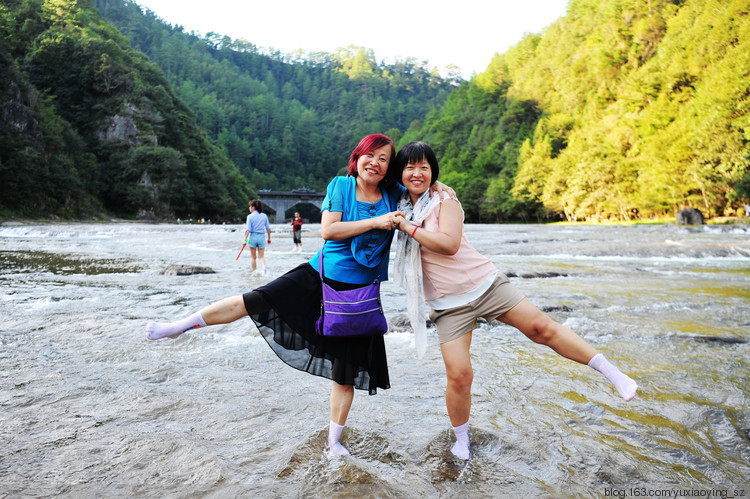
[0,223,750,498]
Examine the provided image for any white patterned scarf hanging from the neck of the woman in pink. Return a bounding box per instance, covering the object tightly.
[394,189,447,359]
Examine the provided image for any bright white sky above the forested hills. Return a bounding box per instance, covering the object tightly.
[135,0,568,79]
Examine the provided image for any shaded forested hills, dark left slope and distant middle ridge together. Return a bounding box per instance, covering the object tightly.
[0,0,452,220]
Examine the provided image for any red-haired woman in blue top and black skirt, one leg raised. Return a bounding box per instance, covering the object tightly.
[146,134,452,455]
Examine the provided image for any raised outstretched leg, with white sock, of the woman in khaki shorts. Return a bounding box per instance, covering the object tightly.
[498,298,638,400]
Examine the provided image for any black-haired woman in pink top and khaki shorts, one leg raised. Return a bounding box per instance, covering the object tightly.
[393,142,638,459]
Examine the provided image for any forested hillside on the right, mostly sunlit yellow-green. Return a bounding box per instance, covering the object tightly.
[404,0,750,221]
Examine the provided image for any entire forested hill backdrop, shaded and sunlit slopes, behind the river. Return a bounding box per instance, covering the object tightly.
[0,0,750,222]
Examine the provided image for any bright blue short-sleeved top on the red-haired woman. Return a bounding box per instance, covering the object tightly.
[310,176,405,284]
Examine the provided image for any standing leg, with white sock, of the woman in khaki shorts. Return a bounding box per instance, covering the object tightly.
[440,332,474,459]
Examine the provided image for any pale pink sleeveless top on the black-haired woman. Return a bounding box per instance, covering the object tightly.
[421,199,497,301]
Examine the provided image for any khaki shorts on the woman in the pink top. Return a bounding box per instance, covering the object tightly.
[430,272,524,343]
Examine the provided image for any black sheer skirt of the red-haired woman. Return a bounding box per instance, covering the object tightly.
[242,263,391,395]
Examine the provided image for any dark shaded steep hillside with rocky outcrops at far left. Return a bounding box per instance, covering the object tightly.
[0,0,252,218]
